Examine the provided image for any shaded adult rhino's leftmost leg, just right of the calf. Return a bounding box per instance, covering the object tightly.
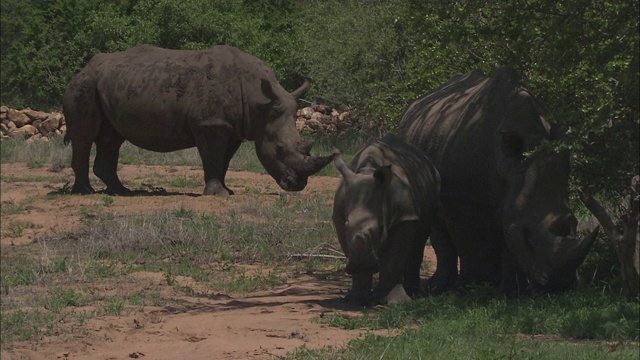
[427,220,458,294]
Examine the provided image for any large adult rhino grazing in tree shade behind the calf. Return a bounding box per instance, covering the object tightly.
[398,67,598,295]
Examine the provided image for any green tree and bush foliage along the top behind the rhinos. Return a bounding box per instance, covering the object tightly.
[0,0,640,194]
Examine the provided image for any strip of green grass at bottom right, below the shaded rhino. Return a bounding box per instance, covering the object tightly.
[296,286,638,359]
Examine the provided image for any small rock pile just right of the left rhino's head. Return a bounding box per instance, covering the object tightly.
[296,105,351,135]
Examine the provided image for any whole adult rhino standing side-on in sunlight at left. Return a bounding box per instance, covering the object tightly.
[63,45,333,195]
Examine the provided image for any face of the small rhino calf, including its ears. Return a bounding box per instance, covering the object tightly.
[334,155,393,275]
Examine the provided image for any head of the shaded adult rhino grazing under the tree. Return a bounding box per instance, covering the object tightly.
[497,90,598,292]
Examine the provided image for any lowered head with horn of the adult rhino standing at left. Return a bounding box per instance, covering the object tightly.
[251,79,333,191]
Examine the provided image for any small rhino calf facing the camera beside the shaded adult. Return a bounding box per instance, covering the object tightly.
[333,134,440,305]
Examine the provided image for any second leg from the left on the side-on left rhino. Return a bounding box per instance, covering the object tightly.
[93,121,130,195]
